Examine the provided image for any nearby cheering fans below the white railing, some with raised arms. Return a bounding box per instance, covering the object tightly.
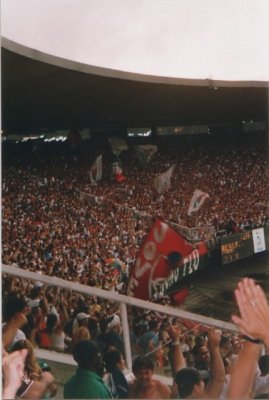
[3,278,269,400]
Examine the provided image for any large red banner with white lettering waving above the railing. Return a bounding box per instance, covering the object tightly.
[127,220,207,300]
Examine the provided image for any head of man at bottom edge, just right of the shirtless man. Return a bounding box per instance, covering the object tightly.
[175,368,205,399]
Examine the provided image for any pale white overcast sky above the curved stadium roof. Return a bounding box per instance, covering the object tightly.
[1,0,269,81]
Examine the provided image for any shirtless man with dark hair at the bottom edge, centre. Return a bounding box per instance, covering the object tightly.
[129,356,171,399]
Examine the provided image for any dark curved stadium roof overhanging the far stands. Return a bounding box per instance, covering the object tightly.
[1,47,268,134]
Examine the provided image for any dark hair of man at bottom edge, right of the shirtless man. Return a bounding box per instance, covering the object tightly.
[175,368,201,398]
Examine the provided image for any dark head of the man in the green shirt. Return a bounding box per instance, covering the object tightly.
[73,339,103,375]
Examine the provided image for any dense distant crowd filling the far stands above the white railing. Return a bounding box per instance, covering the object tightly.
[2,136,269,289]
